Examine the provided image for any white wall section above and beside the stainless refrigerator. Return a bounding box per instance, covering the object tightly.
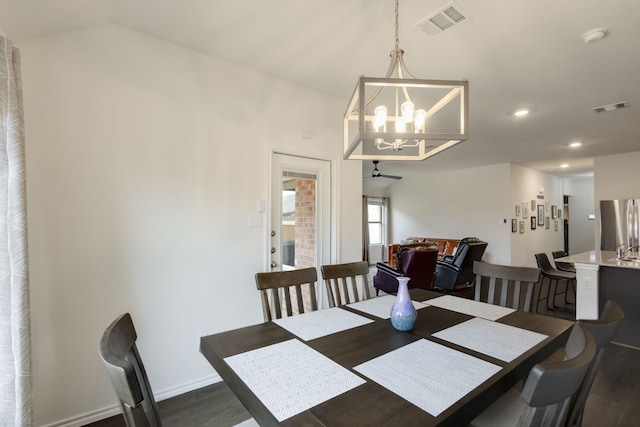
[593,151,640,249]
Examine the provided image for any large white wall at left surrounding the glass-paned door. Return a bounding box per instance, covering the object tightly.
[18,26,362,426]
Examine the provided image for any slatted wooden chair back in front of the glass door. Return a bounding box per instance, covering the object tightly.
[256,267,318,322]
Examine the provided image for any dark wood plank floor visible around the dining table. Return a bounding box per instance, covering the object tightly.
[89,280,640,427]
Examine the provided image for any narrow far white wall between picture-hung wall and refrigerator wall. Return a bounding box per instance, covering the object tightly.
[563,178,598,254]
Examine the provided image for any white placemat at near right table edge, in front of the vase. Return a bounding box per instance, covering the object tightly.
[354,339,501,417]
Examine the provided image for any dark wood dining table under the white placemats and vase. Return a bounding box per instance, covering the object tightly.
[200,289,573,426]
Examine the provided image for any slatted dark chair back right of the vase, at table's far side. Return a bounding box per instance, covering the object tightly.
[473,261,541,312]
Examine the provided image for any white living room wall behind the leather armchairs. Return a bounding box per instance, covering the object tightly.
[388,164,511,263]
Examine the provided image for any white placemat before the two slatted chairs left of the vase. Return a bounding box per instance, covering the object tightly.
[273,307,373,341]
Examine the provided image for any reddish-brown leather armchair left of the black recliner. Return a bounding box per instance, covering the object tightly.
[373,243,438,295]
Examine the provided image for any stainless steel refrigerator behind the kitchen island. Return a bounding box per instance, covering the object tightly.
[600,199,640,254]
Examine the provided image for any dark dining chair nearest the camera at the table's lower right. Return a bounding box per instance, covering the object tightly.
[469,323,596,427]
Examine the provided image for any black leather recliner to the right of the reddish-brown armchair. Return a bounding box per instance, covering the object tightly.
[435,237,487,291]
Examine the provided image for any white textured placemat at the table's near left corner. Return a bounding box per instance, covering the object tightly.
[224,339,366,421]
